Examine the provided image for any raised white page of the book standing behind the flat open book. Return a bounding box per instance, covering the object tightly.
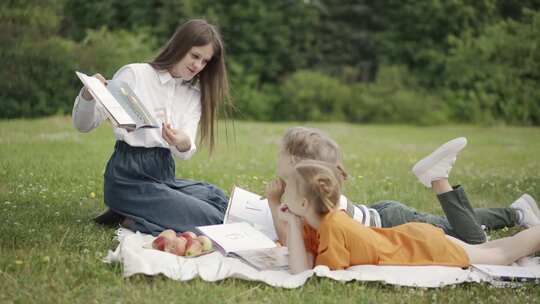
[223,186,278,241]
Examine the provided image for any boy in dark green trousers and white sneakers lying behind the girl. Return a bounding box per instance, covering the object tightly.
[266,127,540,244]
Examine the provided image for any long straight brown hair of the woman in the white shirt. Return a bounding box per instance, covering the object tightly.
[149,19,232,153]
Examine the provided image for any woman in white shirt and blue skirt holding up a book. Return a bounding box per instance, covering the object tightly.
[73,20,229,235]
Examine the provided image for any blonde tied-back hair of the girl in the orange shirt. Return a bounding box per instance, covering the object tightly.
[295,160,344,214]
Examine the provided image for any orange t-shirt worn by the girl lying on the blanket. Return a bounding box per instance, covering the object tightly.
[304,211,470,270]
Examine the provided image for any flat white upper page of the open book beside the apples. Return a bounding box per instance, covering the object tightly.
[197,223,276,254]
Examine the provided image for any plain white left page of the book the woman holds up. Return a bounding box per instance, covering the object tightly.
[75,72,136,125]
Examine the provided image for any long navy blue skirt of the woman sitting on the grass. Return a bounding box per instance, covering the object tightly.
[104,141,228,235]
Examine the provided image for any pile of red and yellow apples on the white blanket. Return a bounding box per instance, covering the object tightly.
[152,229,212,257]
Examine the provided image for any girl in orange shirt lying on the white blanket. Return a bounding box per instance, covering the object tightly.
[280,160,540,273]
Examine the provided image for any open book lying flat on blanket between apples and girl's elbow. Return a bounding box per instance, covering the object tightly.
[197,222,288,270]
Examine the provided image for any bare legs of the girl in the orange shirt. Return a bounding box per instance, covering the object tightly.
[447,226,540,265]
